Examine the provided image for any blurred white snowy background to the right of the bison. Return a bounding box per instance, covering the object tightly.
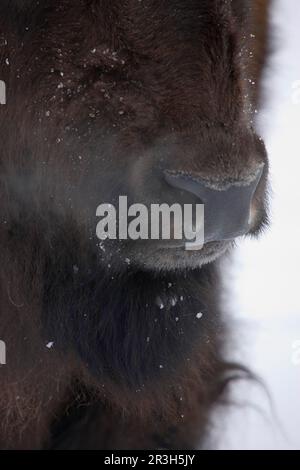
[212,0,300,450]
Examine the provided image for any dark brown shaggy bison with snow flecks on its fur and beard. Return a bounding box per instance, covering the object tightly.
[0,0,269,449]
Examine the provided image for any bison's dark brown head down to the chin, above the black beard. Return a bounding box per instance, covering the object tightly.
[0,0,268,271]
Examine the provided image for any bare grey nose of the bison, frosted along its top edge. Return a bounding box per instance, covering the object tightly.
[165,164,264,243]
